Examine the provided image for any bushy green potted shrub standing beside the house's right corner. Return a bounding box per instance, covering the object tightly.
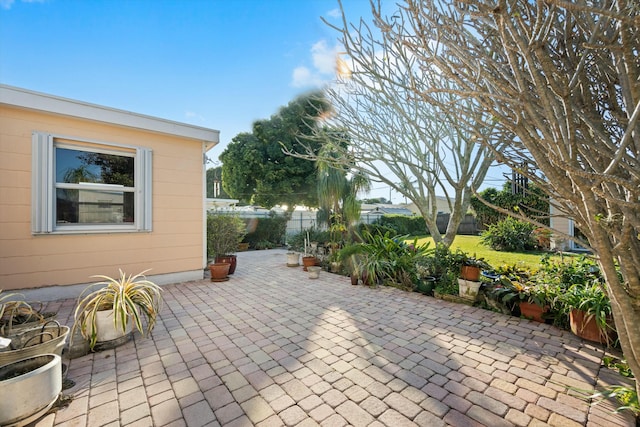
[207,213,246,274]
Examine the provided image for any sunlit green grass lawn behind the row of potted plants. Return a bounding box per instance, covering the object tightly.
[418,236,560,269]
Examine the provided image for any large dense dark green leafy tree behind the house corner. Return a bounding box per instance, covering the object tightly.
[220,93,329,208]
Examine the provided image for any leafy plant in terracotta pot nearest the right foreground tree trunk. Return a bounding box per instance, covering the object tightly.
[560,281,617,346]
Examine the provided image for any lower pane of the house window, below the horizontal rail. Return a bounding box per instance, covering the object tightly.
[56,188,134,224]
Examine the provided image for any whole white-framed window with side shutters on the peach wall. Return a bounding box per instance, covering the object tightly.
[32,132,151,234]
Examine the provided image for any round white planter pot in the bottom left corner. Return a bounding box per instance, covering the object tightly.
[0,354,62,426]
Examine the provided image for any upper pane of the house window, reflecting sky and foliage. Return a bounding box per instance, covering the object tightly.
[56,148,135,187]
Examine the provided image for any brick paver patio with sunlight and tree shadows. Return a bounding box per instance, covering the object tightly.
[37,250,633,427]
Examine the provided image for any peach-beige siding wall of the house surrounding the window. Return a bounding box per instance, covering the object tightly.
[0,106,204,290]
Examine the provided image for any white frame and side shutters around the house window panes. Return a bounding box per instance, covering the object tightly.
[31,132,152,235]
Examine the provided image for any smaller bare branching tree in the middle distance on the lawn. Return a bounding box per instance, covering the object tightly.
[294,7,498,246]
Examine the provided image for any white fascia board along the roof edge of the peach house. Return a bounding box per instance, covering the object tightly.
[0,84,220,147]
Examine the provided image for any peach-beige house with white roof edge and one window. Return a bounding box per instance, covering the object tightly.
[0,85,219,300]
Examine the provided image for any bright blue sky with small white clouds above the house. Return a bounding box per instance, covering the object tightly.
[0,0,510,202]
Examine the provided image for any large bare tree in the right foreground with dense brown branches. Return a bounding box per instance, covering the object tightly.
[364,0,640,389]
